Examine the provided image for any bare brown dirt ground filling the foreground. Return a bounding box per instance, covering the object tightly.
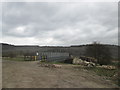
[2,60,117,88]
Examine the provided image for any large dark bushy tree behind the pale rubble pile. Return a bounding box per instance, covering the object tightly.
[85,42,112,65]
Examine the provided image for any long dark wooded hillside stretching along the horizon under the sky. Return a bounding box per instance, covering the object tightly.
[1,43,120,59]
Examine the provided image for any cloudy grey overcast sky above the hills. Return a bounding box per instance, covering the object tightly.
[0,2,118,46]
